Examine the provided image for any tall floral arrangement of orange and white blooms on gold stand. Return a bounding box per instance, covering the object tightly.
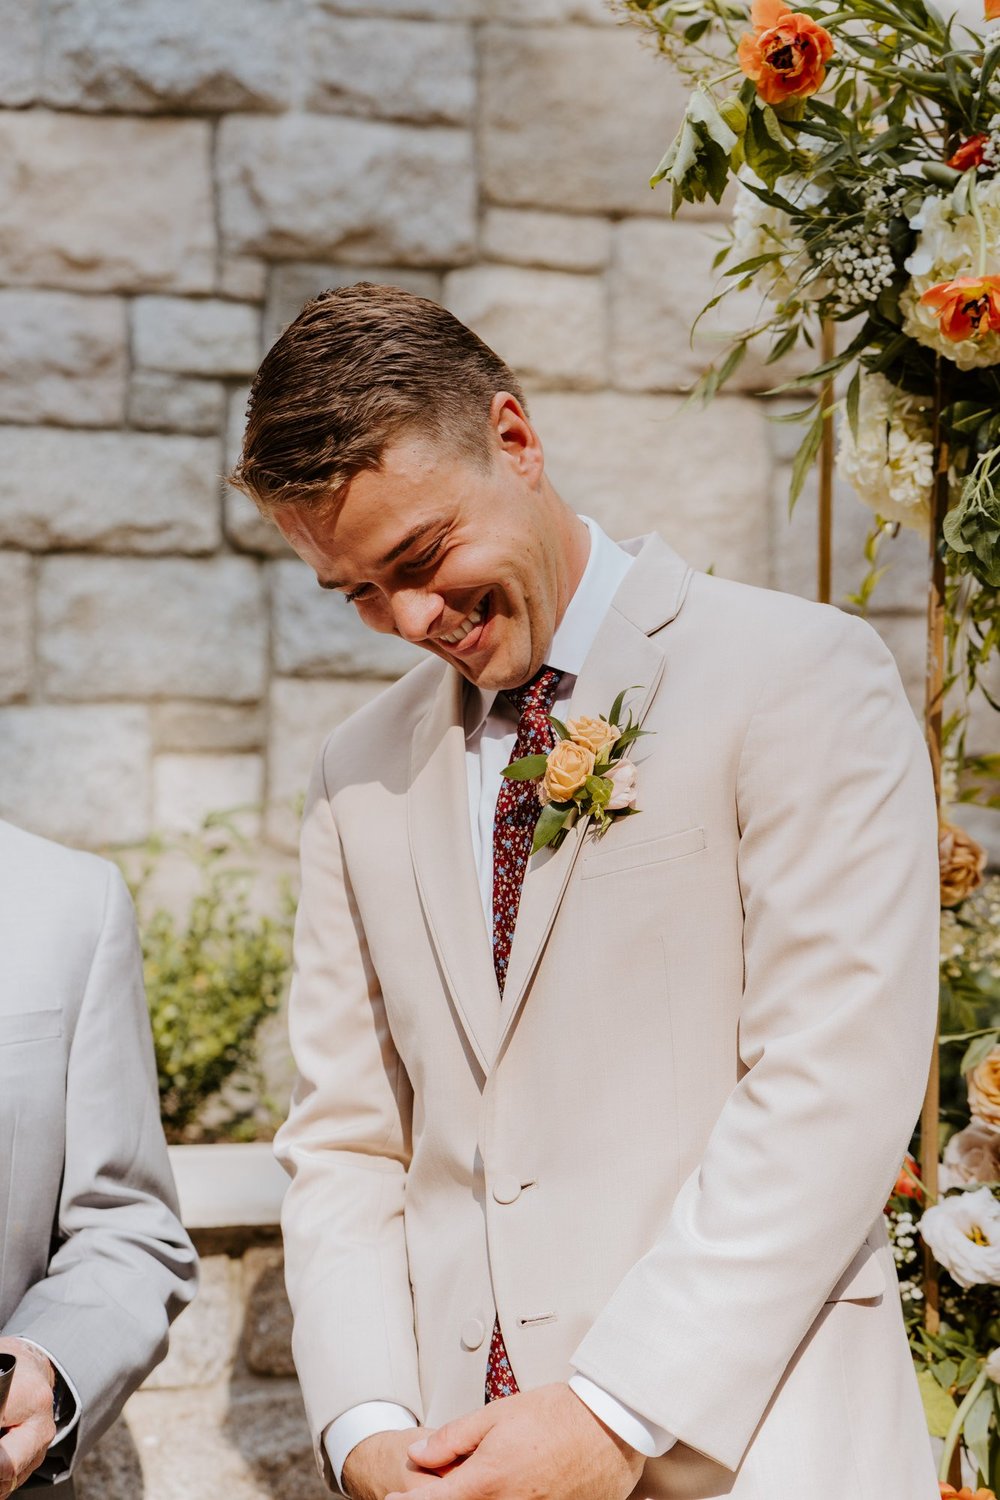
[616,0,1000,1476]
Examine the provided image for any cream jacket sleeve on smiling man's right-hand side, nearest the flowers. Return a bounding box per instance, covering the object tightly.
[573,611,940,1469]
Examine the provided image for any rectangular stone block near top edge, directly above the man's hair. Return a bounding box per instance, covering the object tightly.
[306,9,475,125]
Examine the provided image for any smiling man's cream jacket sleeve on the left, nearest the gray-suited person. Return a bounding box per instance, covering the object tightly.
[276,758,423,1484]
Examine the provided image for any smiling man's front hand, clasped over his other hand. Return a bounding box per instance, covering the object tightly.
[345,1385,645,1500]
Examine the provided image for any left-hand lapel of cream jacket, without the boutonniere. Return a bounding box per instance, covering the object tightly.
[406,668,499,1073]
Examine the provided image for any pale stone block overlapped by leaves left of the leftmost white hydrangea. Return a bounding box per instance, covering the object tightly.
[610,219,819,392]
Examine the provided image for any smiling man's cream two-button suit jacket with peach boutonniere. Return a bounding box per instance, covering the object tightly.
[277,537,939,1500]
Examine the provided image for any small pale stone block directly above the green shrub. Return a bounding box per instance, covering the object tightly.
[153,755,264,839]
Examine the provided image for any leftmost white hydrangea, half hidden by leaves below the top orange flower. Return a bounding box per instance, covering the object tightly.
[729,168,829,306]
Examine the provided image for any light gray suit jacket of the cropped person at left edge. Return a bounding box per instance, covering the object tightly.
[0,822,196,1500]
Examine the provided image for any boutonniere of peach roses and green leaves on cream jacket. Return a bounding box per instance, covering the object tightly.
[502,687,652,854]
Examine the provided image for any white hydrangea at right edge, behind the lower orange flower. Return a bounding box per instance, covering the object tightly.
[900,177,1000,371]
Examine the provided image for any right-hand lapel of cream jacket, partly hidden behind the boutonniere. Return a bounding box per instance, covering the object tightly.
[496,537,691,1055]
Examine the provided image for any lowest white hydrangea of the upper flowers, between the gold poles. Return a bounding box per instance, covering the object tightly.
[837,374,934,536]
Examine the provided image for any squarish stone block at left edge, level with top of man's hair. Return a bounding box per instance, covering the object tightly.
[0,291,127,428]
